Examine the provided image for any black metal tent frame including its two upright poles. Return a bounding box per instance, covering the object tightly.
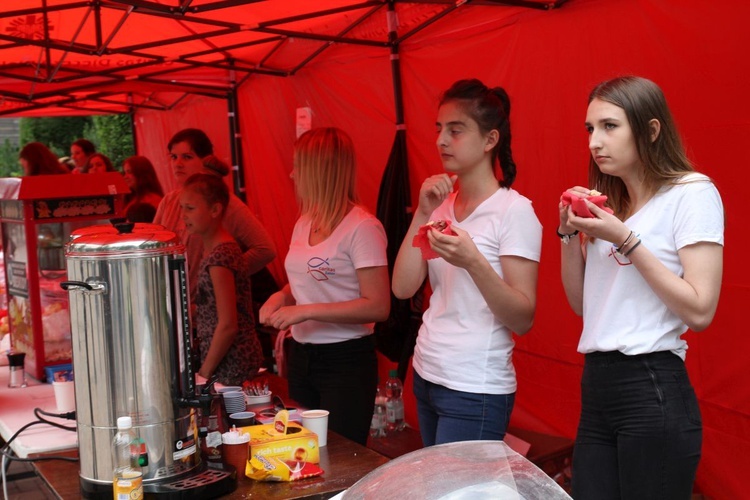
[0,0,567,193]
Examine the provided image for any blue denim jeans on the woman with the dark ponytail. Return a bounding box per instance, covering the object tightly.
[413,371,516,446]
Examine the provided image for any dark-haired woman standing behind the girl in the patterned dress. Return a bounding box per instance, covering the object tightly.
[154,128,276,302]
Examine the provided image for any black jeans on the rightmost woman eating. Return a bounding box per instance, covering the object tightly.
[573,352,702,500]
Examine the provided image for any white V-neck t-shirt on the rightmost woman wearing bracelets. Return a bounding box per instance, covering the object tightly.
[578,173,724,359]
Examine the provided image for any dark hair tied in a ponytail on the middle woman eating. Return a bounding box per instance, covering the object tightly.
[440,78,516,188]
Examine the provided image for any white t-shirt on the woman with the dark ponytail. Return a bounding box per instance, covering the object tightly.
[413,189,542,394]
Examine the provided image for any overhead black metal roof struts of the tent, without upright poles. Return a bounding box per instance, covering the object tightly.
[0,0,566,116]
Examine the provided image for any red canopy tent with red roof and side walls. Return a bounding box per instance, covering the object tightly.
[0,0,750,498]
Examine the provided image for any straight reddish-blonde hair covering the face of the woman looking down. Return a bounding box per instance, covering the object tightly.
[294,127,358,234]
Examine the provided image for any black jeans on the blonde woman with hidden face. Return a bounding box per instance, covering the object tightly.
[287,335,378,445]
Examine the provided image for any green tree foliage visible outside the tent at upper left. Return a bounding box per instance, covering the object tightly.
[16,114,135,172]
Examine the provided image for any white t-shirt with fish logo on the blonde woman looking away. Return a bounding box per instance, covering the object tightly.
[284,206,388,344]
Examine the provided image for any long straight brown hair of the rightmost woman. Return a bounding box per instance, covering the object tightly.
[589,76,694,219]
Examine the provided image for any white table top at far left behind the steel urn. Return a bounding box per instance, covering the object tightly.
[0,367,78,458]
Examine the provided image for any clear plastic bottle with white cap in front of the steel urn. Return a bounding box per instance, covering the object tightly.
[112,417,143,500]
